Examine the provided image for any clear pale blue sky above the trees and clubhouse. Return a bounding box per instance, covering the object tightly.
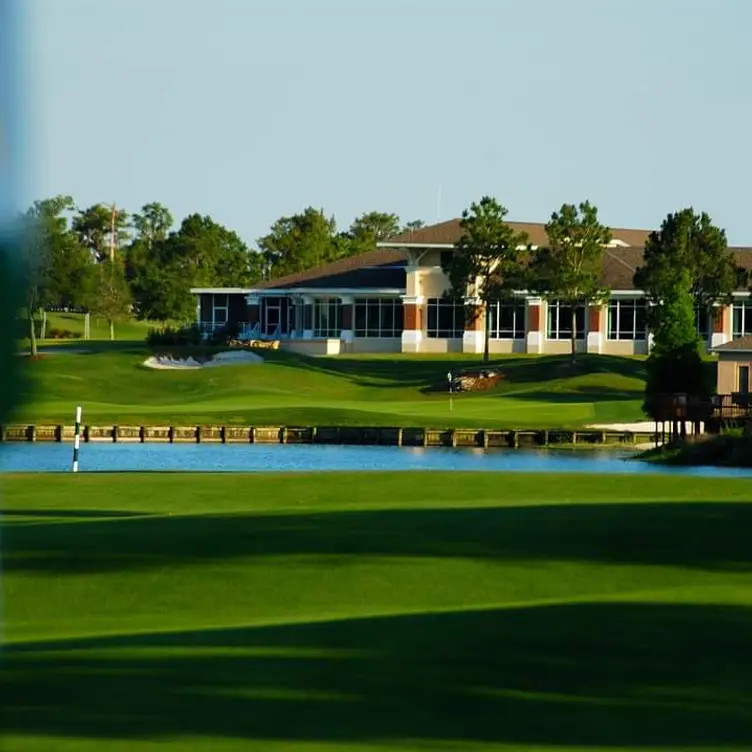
[23,0,752,245]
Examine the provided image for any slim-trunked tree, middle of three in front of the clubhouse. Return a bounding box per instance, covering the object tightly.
[528,201,611,362]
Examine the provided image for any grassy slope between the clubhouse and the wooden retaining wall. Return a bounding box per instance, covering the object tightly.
[11,345,644,428]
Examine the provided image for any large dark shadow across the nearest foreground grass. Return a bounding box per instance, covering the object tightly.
[0,603,752,749]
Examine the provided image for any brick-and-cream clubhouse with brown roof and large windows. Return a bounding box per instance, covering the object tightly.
[192,220,752,364]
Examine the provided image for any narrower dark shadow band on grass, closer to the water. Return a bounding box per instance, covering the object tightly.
[3,500,752,575]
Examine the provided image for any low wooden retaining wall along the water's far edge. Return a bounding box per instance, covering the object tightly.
[0,425,656,449]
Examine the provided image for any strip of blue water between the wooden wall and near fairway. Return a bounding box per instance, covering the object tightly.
[0,443,752,478]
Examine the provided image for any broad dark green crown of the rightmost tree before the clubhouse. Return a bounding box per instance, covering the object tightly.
[634,209,745,332]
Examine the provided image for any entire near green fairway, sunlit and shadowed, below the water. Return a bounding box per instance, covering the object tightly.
[0,473,752,752]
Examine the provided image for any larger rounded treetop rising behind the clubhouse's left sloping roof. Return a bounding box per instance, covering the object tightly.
[257,207,340,279]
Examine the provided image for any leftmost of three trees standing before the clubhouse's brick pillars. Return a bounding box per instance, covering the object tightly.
[442,196,528,362]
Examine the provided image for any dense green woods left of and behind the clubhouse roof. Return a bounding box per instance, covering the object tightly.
[22,196,423,352]
